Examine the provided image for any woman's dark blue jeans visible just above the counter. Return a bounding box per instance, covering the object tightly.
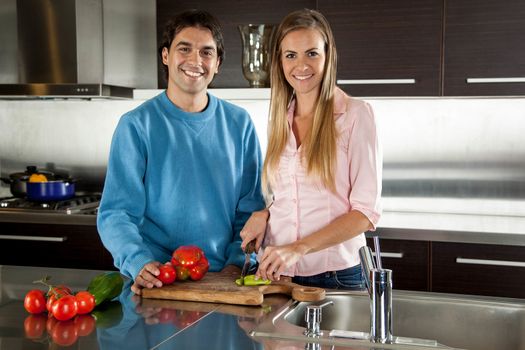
[292,264,365,290]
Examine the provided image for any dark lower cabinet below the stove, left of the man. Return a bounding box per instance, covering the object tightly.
[0,222,115,270]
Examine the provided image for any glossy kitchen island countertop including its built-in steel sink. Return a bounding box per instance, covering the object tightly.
[0,265,525,350]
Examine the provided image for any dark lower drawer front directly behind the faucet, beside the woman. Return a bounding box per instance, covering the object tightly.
[367,238,430,291]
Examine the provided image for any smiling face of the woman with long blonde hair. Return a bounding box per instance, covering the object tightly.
[281,29,326,94]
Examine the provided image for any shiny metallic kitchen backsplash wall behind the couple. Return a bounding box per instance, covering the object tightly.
[0,89,525,216]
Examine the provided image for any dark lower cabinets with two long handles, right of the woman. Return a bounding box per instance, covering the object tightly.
[374,235,525,298]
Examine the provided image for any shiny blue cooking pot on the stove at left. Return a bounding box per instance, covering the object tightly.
[27,179,75,202]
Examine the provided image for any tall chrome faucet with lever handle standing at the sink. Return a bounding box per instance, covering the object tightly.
[359,237,393,343]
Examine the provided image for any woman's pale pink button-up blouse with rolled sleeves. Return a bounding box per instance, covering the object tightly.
[264,89,382,276]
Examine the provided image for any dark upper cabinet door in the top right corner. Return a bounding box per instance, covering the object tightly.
[444,0,525,96]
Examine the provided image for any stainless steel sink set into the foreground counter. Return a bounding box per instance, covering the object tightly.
[252,291,525,350]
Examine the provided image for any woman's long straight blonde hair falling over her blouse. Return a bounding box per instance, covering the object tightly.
[262,9,337,194]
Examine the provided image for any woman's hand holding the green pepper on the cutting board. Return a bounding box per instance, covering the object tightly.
[255,242,306,281]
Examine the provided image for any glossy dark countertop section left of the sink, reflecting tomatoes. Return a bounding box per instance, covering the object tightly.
[0,265,344,350]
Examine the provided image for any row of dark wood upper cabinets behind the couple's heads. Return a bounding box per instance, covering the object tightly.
[157,0,525,96]
